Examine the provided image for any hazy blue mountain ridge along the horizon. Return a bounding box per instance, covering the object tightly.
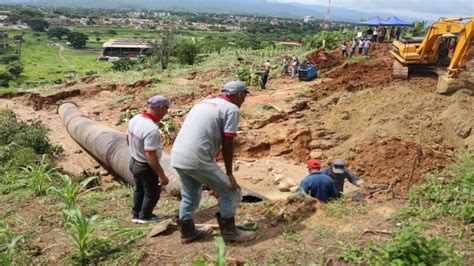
[0,0,414,21]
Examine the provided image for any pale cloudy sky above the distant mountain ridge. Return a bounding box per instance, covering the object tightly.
[273,0,474,20]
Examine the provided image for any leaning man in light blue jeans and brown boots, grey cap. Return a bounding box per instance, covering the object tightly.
[171,81,256,243]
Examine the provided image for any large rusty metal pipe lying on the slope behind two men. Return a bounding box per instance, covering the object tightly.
[58,102,265,202]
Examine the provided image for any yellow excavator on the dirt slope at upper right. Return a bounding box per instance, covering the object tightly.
[390,17,474,92]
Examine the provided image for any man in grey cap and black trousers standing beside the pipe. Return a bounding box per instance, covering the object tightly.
[127,95,171,224]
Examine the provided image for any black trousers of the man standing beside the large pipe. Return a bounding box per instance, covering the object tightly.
[130,159,161,219]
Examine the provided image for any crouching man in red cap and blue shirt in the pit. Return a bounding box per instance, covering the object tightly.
[300,159,339,203]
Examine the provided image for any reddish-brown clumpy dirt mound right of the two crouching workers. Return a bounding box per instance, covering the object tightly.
[348,138,449,191]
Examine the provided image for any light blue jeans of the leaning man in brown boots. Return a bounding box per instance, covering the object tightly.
[176,164,242,220]
